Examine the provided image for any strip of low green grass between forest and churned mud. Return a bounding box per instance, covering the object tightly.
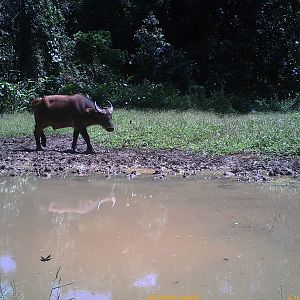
[0,110,300,154]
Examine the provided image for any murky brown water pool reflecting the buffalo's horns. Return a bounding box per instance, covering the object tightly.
[0,177,300,300]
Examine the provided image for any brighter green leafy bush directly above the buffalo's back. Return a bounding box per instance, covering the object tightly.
[53,31,127,98]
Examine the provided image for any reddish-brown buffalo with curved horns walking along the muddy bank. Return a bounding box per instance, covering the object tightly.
[32,94,114,153]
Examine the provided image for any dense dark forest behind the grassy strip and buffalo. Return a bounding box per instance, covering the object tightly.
[0,0,300,112]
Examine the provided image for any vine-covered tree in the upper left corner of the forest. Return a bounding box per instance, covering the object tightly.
[0,0,67,78]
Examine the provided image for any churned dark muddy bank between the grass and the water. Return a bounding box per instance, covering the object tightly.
[0,136,300,181]
